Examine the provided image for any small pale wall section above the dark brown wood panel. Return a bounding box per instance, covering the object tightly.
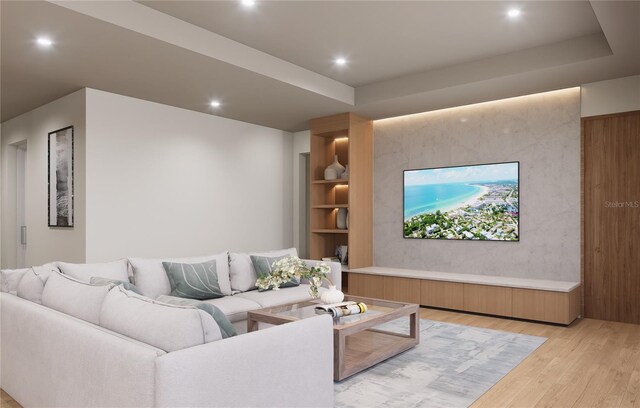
[581,75,640,117]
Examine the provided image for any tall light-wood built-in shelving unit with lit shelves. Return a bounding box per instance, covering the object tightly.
[310,113,373,268]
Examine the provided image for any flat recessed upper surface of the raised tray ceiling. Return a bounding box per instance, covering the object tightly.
[140,1,602,87]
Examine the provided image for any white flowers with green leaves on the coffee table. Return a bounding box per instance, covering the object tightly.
[256,256,333,299]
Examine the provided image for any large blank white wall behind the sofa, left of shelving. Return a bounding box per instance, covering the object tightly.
[87,89,293,262]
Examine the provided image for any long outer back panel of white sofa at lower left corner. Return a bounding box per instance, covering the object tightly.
[0,293,165,408]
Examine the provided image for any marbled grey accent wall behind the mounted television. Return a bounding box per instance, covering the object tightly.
[374,88,580,281]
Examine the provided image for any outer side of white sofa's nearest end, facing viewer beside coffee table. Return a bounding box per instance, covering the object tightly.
[155,315,334,407]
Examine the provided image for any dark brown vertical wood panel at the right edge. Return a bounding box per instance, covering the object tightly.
[582,111,640,323]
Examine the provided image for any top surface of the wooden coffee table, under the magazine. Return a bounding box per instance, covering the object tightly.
[249,295,419,330]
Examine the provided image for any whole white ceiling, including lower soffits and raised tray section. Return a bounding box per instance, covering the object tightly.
[0,0,640,131]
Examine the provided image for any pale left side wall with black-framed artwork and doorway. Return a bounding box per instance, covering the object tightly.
[1,90,85,268]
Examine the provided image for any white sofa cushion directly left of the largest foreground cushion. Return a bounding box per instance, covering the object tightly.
[42,272,112,324]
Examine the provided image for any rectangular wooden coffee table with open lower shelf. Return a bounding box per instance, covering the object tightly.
[247,296,420,381]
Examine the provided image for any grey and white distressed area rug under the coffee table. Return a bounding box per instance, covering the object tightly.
[335,319,546,408]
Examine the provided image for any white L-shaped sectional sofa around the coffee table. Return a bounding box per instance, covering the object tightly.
[0,253,341,407]
